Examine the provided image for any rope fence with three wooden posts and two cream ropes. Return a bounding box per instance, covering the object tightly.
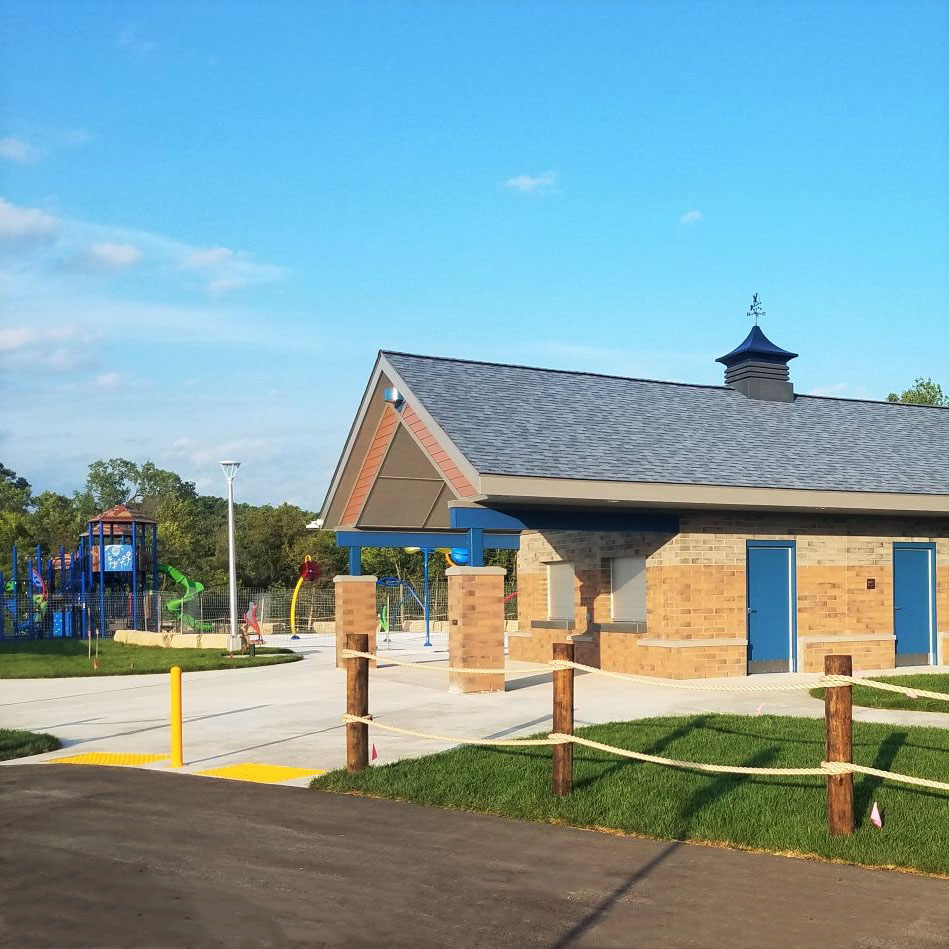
[340,633,949,836]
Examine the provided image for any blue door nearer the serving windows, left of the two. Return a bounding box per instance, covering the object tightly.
[747,540,796,672]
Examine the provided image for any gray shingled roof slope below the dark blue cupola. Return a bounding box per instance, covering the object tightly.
[384,352,949,494]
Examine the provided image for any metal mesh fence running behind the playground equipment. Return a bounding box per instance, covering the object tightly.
[0,580,517,639]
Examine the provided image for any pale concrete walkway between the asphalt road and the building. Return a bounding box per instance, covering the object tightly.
[0,636,949,784]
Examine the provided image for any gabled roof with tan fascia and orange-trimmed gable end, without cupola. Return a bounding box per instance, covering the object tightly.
[323,352,949,530]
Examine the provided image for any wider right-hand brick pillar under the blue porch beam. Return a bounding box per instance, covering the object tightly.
[445,567,507,692]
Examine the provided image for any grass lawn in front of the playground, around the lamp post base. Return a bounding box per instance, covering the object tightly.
[0,639,303,679]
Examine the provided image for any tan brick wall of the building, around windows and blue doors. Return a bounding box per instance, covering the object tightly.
[509,512,949,677]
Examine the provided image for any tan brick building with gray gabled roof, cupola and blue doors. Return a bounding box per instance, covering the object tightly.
[323,326,949,677]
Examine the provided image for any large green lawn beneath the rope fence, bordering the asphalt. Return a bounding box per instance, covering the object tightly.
[311,714,949,874]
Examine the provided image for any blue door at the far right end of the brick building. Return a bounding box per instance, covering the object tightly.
[893,543,936,666]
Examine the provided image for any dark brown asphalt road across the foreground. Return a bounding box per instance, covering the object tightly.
[0,765,949,949]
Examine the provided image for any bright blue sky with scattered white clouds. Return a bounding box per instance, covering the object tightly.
[0,0,949,508]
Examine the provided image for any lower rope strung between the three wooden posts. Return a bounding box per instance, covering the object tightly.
[343,713,949,791]
